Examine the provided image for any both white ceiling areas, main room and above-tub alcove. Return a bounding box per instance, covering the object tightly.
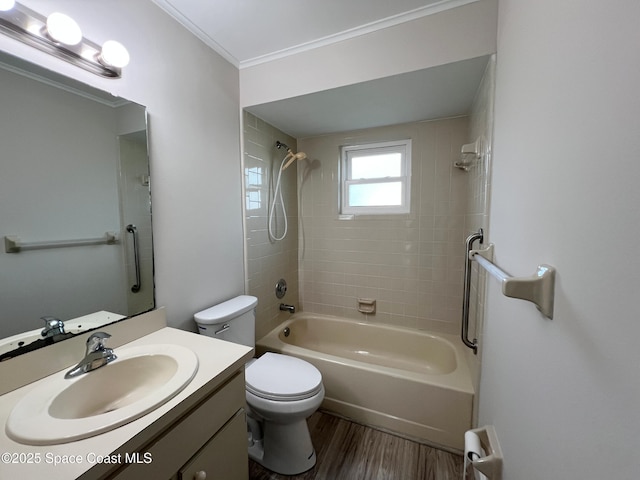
[153,0,487,138]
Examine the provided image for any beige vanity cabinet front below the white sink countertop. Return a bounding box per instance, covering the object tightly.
[102,370,249,480]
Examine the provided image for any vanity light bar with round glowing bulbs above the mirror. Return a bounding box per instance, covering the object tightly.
[0,0,129,78]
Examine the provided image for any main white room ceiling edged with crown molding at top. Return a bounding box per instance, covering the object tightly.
[153,0,474,68]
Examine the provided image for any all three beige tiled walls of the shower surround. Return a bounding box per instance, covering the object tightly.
[244,58,495,342]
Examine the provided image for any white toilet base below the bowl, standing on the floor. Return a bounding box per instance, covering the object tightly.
[249,419,316,475]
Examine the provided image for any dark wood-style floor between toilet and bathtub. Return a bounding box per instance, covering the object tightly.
[249,411,463,480]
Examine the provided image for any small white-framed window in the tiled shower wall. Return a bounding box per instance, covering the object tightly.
[340,140,411,215]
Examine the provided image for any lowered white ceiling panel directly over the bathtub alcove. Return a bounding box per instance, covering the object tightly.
[246,57,488,138]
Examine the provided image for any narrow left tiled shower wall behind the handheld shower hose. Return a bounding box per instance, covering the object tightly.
[243,112,298,338]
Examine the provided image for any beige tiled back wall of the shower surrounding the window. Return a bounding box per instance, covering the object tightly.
[298,117,469,333]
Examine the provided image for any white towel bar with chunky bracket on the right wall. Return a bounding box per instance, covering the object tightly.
[469,244,556,319]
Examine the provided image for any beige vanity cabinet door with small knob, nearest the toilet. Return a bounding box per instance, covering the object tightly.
[180,411,249,480]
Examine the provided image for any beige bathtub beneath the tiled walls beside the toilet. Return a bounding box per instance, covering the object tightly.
[256,312,474,451]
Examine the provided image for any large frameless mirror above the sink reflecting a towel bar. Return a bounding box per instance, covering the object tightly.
[0,52,155,361]
